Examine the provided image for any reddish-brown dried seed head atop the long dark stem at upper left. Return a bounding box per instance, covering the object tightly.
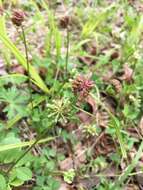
[11,10,25,26]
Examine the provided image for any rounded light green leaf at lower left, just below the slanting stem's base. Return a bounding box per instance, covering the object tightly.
[16,167,32,181]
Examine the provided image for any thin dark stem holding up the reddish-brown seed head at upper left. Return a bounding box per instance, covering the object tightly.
[21,25,33,111]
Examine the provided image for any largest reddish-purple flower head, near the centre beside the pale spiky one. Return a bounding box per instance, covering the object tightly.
[72,75,93,99]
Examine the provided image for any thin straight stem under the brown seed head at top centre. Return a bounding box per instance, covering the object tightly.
[65,26,70,77]
